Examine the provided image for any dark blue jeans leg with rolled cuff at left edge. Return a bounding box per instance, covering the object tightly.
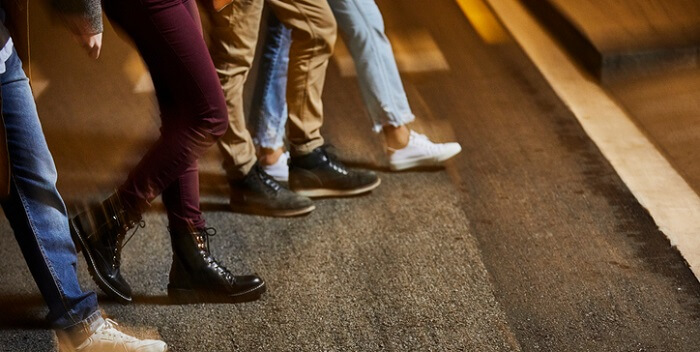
[0,49,102,335]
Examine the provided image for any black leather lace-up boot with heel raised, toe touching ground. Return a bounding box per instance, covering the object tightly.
[70,193,143,304]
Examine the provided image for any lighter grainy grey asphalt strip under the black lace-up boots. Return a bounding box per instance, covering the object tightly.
[0,166,519,351]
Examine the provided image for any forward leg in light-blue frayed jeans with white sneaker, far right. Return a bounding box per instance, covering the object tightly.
[328,0,461,170]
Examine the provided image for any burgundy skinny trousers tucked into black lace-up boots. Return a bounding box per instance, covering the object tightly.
[102,0,228,228]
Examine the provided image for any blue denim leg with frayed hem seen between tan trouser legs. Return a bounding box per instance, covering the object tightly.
[253,12,292,149]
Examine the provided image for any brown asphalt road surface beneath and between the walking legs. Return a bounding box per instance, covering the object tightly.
[0,0,700,351]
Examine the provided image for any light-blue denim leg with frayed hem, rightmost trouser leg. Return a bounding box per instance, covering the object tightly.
[328,0,415,131]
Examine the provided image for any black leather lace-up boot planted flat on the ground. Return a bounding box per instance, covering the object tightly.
[168,227,266,303]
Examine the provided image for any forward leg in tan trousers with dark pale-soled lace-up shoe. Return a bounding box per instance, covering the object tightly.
[258,0,381,197]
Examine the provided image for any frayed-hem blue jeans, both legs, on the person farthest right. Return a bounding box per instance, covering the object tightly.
[254,0,415,149]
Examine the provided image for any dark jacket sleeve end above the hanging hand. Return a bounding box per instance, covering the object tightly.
[51,0,103,34]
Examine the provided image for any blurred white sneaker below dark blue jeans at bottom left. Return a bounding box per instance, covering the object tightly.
[75,319,168,352]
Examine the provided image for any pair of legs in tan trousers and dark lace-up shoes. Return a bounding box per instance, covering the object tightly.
[202,0,380,216]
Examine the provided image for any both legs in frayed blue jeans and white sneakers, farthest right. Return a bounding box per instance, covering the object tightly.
[253,0,461,178]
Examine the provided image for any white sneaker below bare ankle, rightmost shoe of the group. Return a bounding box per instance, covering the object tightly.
[387,131,462,171]
